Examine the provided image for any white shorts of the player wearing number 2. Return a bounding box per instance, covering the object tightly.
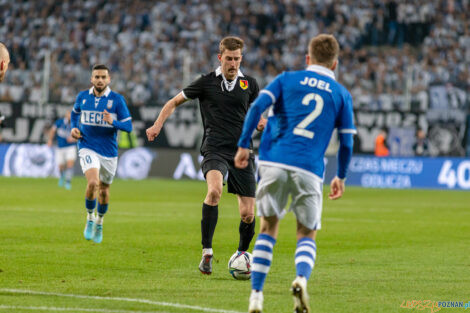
[256,165,323,230]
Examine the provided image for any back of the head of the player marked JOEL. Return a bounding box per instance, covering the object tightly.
[306,34,339,70]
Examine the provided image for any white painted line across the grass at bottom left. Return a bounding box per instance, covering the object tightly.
[0,288,242,313]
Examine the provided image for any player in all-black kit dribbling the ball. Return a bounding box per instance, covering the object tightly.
[147,37,266,275]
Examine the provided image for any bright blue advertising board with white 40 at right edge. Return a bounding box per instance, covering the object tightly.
[325,156,470,190]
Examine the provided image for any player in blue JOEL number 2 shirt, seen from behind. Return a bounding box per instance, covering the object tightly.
[235,34,356,313]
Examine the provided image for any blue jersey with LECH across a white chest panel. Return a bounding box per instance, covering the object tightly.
[72,87,132,157]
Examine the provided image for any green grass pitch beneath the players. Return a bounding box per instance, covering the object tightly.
[0,177,470,313]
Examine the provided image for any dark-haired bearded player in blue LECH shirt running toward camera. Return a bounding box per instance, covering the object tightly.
[71,64,132,243]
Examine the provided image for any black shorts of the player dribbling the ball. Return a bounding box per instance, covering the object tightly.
[201,152,256,198]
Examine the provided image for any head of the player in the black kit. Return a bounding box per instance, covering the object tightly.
[217,36,243,80]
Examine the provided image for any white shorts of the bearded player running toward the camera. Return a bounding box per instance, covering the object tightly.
[78,148,117,185]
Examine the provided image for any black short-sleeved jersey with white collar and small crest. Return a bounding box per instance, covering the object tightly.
[183,69,259,156]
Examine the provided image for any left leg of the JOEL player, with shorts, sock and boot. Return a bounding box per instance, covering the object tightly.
[248,166,289,313]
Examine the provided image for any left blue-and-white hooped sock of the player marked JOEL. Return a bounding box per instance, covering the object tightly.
[251,234,276,291]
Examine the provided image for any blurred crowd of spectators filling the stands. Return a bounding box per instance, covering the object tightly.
[0,0,470,106]
